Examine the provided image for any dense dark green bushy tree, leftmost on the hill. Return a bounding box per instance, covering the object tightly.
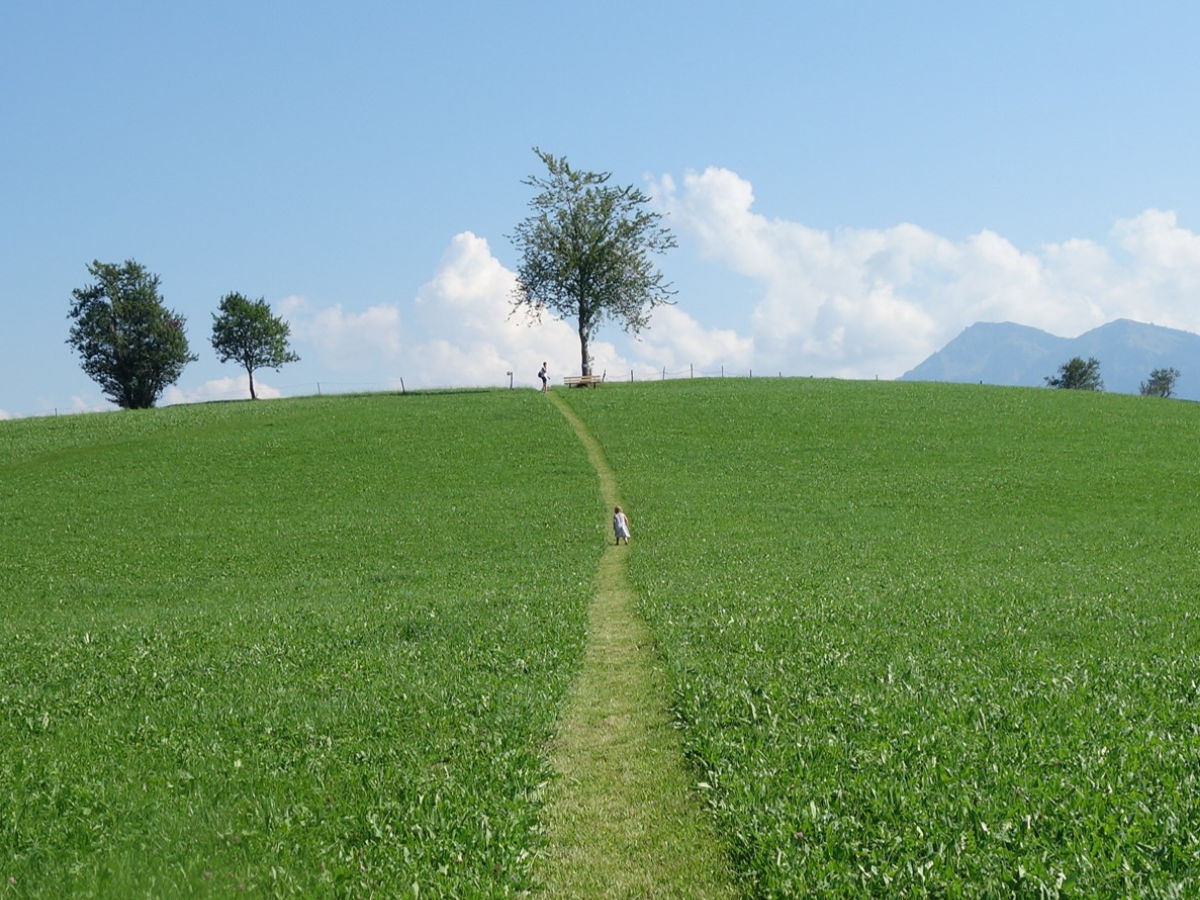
[67,259,198,409]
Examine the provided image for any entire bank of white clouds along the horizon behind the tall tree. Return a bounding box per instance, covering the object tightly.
[270,168,1200,392]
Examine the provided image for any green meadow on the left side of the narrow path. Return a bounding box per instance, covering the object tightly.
[0,391,604,898]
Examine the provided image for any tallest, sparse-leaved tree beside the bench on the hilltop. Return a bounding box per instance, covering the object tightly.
[511,148,676,374]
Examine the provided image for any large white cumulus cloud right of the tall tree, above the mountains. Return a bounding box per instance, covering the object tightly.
[655,168,1200,378]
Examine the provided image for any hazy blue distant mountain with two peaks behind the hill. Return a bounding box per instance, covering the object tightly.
[900,319,1200,400]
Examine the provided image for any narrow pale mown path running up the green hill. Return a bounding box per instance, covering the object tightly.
[540,391,737,899]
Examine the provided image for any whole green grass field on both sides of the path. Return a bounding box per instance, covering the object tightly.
[0,379,1200,898]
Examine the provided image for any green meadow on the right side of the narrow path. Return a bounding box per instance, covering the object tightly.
[571,379,1200,898]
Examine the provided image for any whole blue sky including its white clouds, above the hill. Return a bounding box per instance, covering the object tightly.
[0,0,1200,418]
